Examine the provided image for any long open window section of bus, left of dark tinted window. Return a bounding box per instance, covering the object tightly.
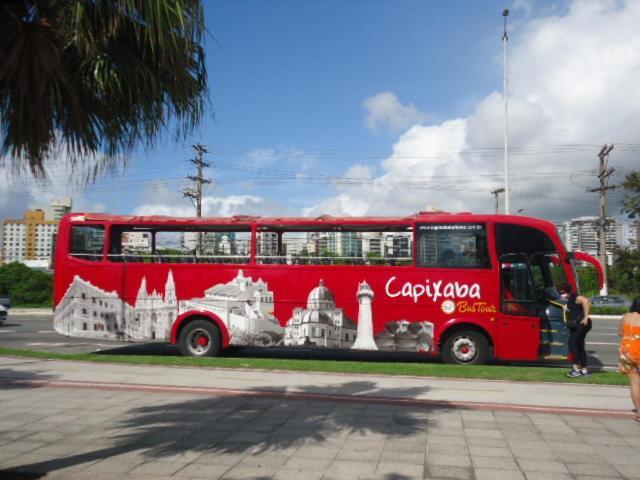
[256,226,413,266]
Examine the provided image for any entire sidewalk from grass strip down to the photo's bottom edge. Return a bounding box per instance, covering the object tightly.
[0,357,640,480]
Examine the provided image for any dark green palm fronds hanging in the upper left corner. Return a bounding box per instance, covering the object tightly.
[0,0,207,178]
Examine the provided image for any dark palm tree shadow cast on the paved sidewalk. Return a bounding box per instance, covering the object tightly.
[0,381,433,480]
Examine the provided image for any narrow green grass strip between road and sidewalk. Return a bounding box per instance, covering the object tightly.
[0,347,629,385]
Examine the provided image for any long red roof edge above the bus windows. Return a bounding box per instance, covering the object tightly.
[65,212,555,231]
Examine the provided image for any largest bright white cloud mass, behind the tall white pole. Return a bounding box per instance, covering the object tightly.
[305,0,640,219]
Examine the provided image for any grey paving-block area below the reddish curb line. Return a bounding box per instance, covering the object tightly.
[0,378,640,480]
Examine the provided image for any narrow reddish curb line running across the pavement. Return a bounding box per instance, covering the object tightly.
[0,377,635,418]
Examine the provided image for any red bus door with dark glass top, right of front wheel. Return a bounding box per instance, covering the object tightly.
[496,253,540,360]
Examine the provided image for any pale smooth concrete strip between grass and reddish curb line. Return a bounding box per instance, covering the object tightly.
[0,357,632,416]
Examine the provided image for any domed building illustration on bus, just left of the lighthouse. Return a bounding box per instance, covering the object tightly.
[284,280,356,348]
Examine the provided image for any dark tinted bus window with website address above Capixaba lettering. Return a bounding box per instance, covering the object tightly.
[418,223,491,268]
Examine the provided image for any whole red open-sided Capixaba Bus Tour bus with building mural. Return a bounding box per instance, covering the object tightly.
[54,213,600,363]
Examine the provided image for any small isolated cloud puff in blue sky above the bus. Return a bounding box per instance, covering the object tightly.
[363,92,428,132]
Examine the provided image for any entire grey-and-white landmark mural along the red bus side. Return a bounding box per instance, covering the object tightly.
[53,270,434,352]
